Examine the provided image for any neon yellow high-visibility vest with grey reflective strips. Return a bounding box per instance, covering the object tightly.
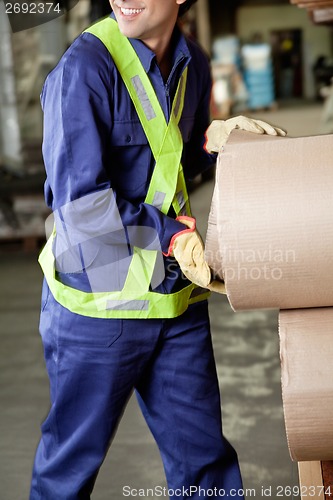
[39,18,209,319]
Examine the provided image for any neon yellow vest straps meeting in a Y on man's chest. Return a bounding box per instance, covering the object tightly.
[86,17,190,215]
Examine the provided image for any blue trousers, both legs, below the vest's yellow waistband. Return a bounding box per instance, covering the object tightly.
[30,287,240,500]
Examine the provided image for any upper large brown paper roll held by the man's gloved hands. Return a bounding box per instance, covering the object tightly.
[206,131,333,310]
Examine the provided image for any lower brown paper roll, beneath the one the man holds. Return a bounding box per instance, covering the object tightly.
[279,307,333,461]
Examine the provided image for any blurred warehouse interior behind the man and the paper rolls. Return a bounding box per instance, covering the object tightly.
[0,0,333,500]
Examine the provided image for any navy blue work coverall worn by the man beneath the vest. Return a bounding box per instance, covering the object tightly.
[30,15,243,500]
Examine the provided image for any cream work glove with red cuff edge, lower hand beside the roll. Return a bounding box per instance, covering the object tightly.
[164,216,225,293]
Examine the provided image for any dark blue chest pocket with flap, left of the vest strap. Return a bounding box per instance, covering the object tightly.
[109,121,152,199]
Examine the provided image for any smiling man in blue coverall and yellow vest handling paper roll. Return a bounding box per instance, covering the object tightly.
[30,0,277,500]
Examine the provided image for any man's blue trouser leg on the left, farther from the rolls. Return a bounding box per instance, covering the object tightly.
[30,287,158,500]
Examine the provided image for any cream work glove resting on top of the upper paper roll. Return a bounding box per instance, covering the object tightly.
[205,116,287,153]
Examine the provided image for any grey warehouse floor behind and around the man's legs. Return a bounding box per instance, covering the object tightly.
[0,98,322,500]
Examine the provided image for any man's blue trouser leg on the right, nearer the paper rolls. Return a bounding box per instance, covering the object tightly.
[137,302,243,500]
